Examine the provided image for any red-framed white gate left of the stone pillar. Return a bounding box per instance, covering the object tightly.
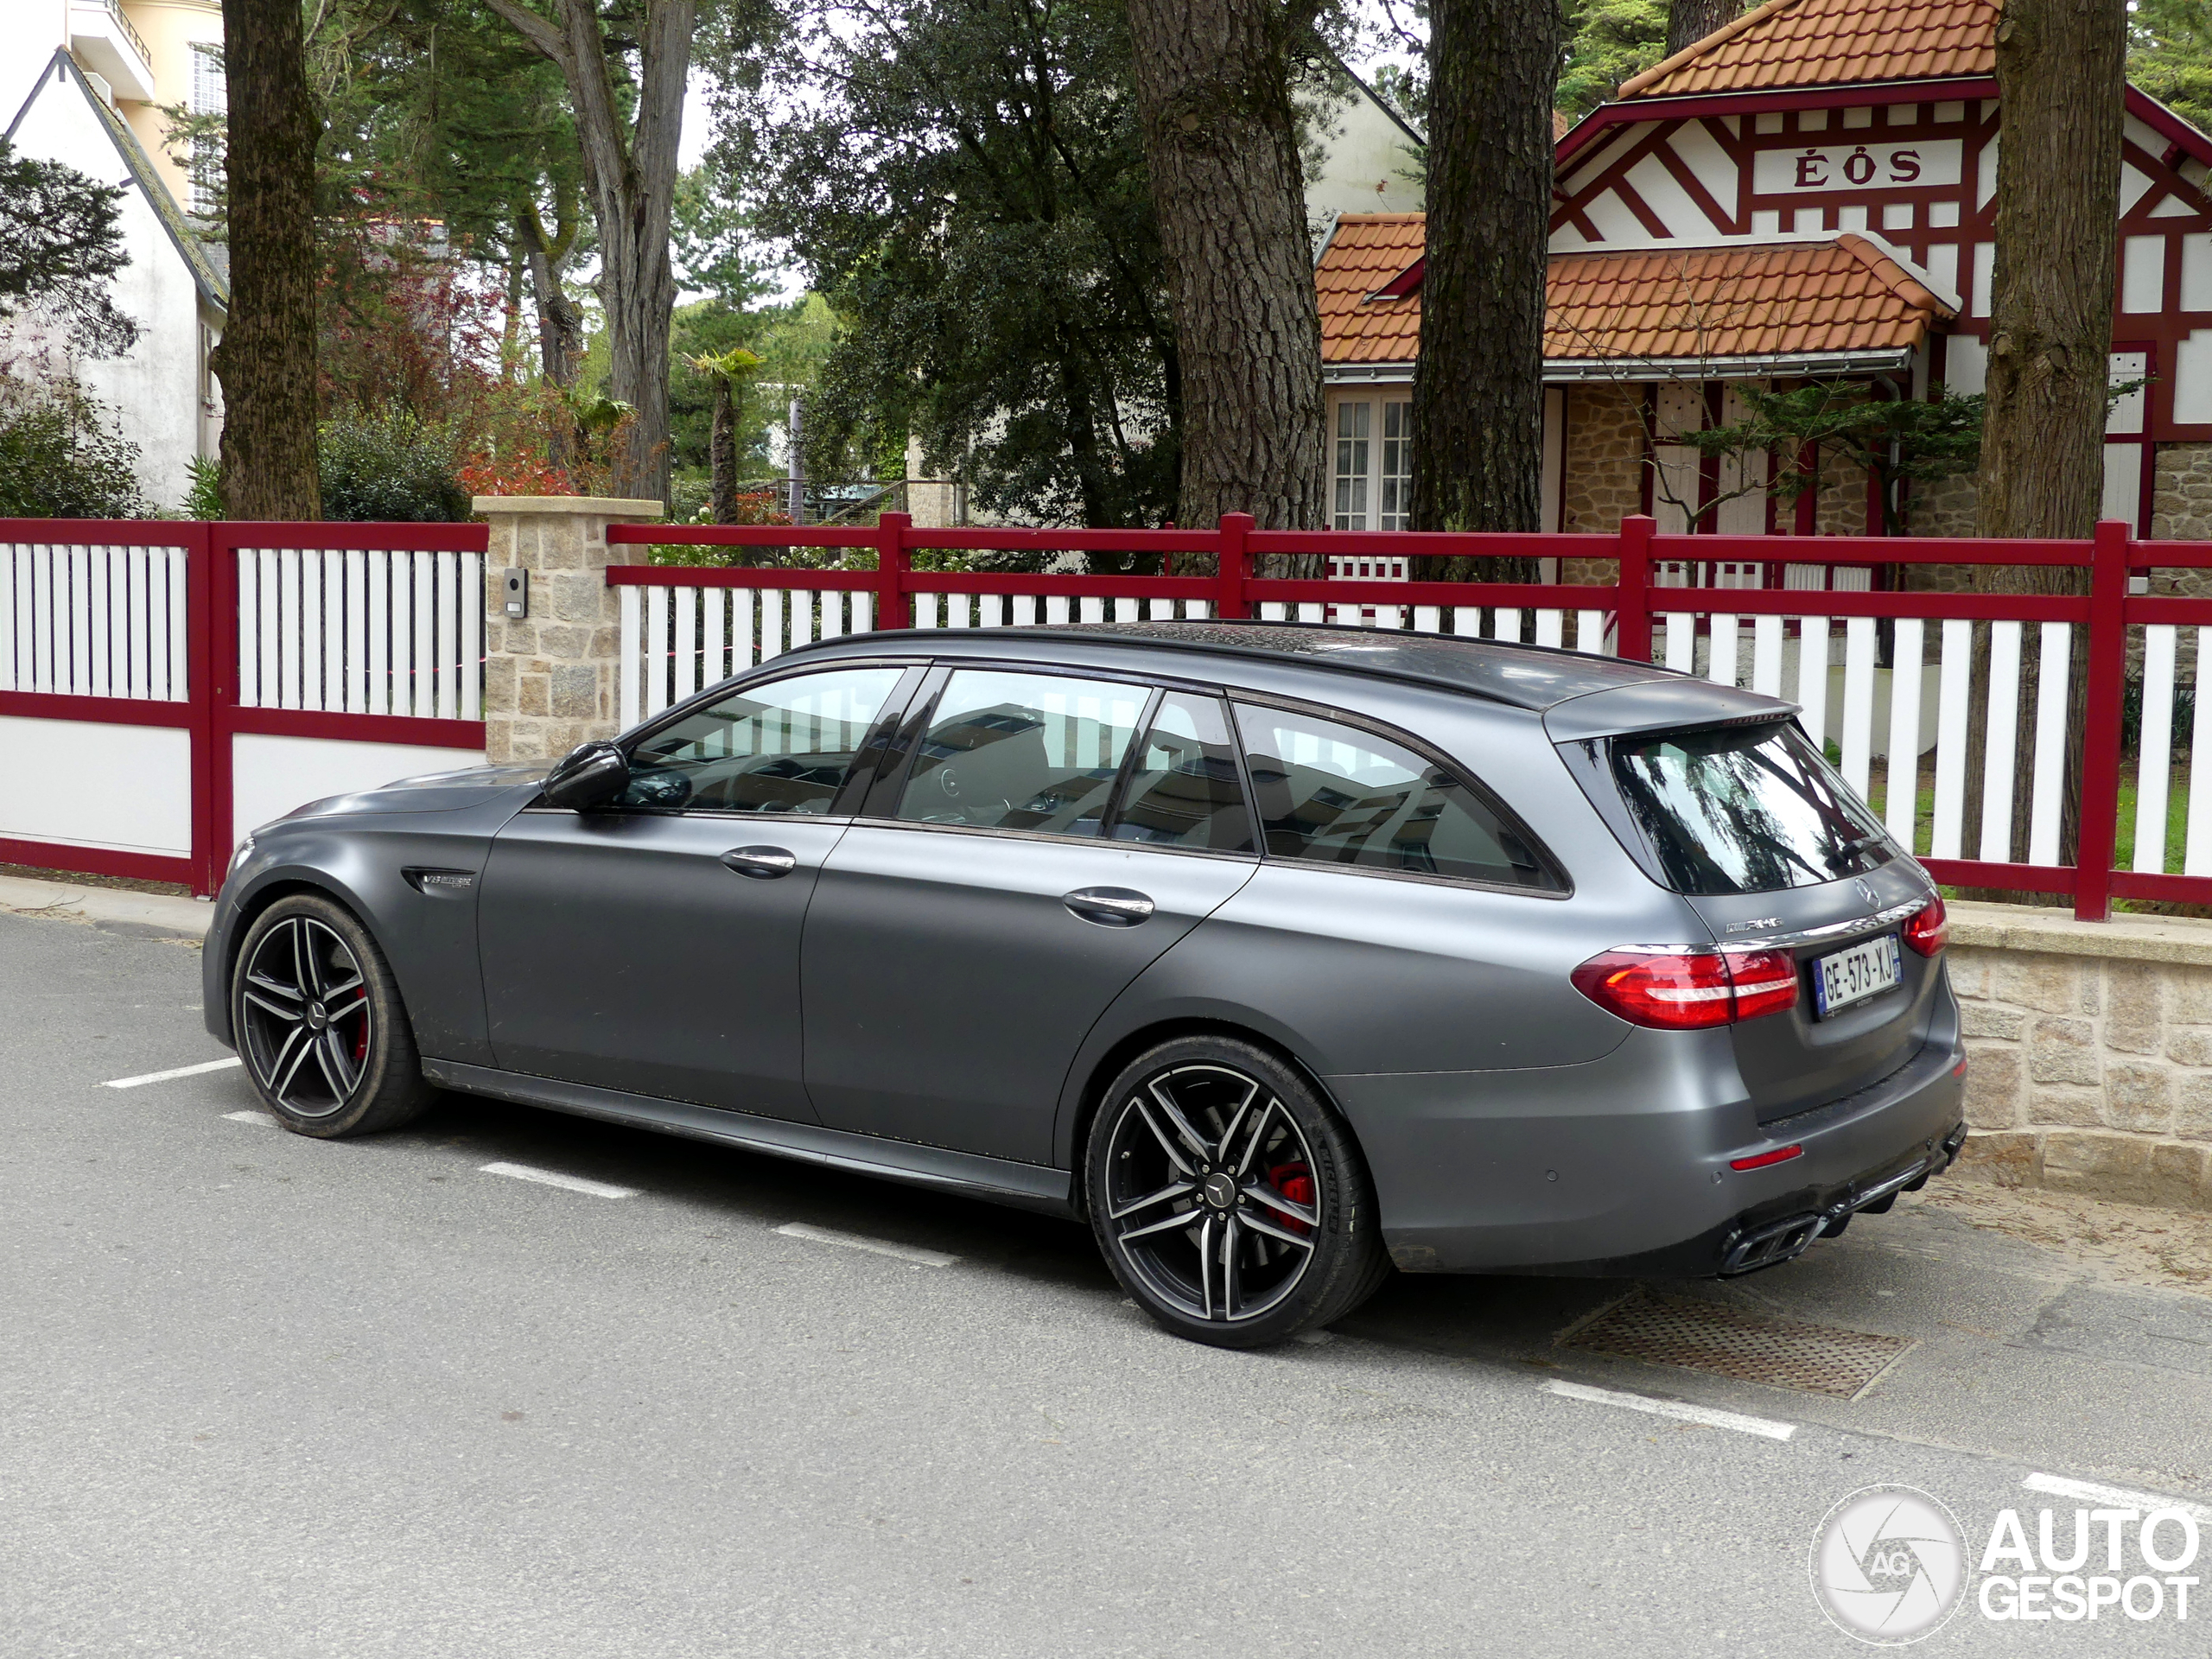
[0,520,486,893]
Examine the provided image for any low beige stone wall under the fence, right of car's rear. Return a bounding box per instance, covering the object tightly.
[1947,905,2212,1210]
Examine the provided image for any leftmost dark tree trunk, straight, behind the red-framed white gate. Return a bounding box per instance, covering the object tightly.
[210,0,323,520]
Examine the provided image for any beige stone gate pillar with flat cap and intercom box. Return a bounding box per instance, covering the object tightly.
[475,495,661,761]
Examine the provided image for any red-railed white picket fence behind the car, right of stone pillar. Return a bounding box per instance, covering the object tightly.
[606,513,2212,920]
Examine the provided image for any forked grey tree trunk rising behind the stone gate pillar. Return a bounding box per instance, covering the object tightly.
[486,0,699,505]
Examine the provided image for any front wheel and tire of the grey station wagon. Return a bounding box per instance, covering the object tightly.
[230,893,435,1141]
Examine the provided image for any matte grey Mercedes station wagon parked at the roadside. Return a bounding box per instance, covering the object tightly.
[206,621,1964,1347]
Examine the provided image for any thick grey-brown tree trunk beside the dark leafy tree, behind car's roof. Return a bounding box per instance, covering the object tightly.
[1128,0,1327,529]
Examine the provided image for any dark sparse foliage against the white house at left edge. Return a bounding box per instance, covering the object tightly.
[0,137,137,356]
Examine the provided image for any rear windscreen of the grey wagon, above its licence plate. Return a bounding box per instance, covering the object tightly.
[1612,723,1897,893]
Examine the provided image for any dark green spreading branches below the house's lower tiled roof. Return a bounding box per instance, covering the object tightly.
[1655,380,1986,536]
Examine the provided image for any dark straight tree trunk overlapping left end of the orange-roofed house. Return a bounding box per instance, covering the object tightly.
[1414,0,1560,580]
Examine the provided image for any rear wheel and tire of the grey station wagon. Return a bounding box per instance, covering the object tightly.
[1084,1035,1391,1347]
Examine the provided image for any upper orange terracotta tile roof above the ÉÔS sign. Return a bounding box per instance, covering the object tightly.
[1619,0,1999,98]
